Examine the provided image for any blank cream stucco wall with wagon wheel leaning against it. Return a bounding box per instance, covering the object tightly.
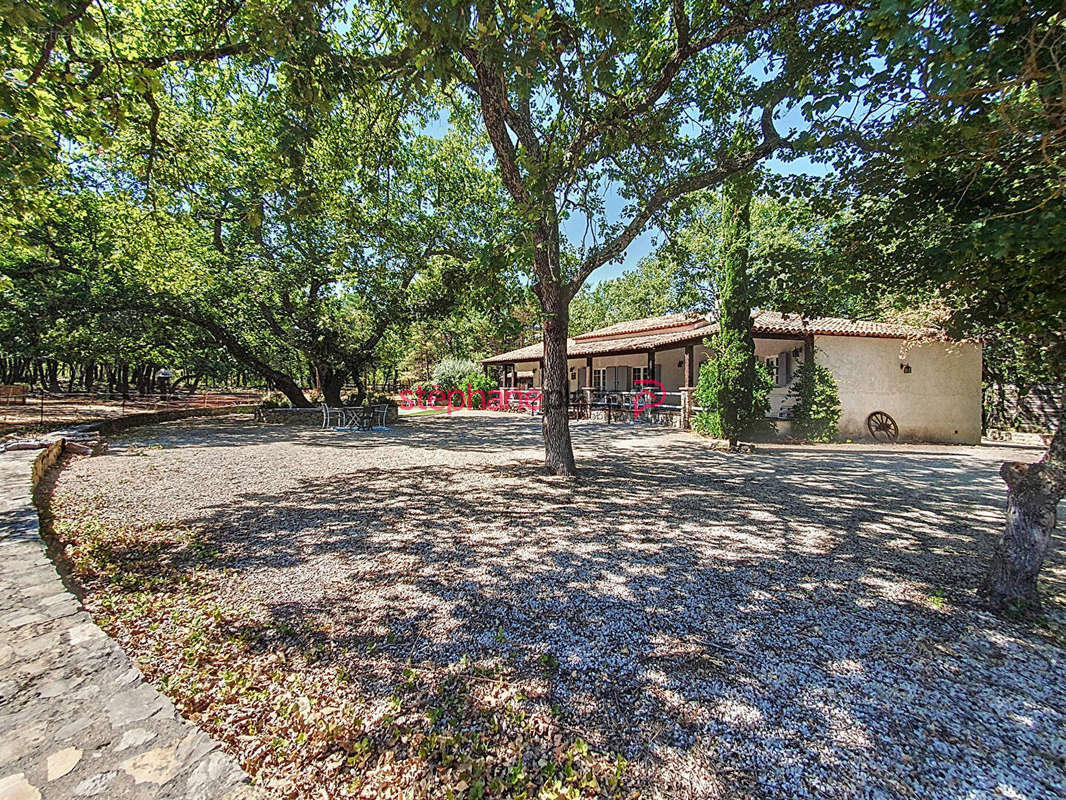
[814,336,981,444]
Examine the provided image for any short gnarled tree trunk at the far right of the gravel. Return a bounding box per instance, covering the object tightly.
[981,413,1066,614]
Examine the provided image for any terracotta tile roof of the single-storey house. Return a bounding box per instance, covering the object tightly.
[482,311,944,364]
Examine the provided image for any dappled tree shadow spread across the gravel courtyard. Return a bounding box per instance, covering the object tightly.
[60,415,1066,797]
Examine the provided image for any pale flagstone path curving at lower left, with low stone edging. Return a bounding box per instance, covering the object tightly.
[0,406,263,800]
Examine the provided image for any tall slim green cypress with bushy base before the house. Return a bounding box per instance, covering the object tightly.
[694,176,770,449]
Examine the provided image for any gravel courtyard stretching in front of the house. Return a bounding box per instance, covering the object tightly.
[47,413,1066,798]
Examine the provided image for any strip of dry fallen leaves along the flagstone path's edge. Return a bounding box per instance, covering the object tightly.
[47,502,635,800]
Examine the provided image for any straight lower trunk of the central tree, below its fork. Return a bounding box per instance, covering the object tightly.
[539,284,577,476]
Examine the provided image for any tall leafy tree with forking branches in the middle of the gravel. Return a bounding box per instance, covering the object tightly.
[360,0,895,475]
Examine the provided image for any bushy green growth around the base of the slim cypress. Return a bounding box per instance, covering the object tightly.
[692,342,774,438]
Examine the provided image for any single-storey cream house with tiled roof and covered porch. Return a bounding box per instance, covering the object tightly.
[482,310,981,444]
